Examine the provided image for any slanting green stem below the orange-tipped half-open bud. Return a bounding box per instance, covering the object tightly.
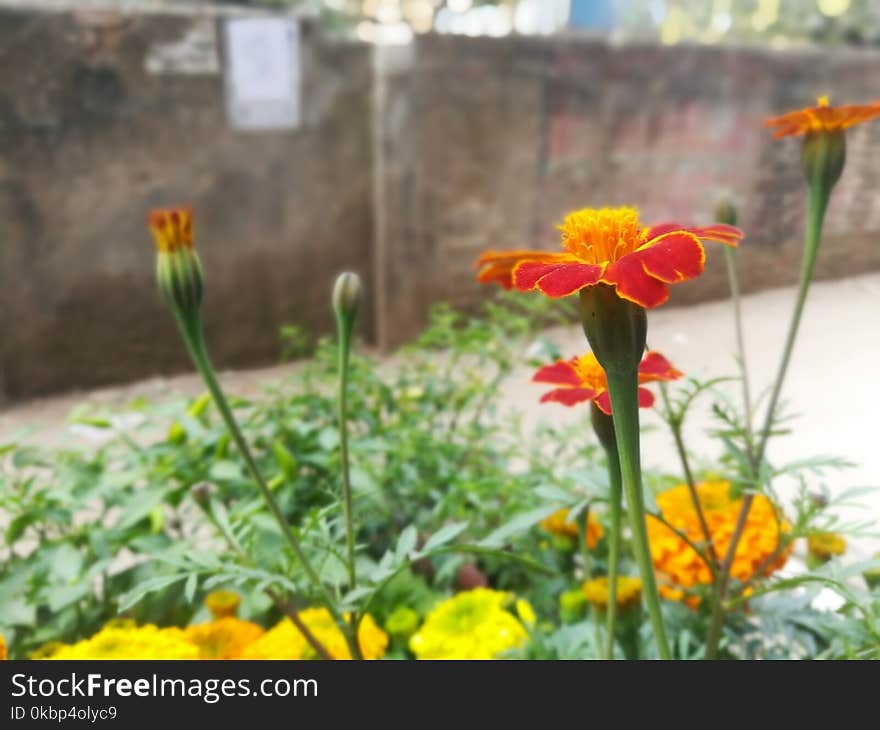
[175,312,341,622]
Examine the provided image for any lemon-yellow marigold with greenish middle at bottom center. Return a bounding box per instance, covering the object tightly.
[409,588,534,659]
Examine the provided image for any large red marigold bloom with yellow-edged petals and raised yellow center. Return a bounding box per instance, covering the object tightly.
[476,207,743,309]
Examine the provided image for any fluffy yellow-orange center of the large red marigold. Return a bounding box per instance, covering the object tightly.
[559,207,644,264]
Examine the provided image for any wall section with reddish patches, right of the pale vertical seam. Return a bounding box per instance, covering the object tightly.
[377,36,880,342]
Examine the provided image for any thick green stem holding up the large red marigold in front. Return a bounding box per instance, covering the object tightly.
[606,368,672,659]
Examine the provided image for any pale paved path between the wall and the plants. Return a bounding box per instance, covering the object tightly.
[6,274,880,556]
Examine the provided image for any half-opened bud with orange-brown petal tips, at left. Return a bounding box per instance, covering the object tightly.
[148,208,203,314]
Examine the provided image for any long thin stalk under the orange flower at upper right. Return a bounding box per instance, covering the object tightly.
[706,180,831,659]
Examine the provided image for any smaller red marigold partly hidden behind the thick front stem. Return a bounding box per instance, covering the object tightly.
[532,350,682,416]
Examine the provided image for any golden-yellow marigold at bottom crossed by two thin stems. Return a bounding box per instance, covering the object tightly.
[242,608,388,659]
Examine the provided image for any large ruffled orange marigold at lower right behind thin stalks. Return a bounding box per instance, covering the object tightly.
[648,481,792,607]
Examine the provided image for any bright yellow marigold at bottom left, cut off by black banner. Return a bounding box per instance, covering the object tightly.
[38,624,199,659]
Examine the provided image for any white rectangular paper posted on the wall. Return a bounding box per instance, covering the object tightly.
[224,18,300,131]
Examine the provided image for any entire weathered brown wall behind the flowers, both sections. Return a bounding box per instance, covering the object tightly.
[0,2,880,401]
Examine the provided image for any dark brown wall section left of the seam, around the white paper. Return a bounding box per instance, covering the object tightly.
[0,4,373,399]
